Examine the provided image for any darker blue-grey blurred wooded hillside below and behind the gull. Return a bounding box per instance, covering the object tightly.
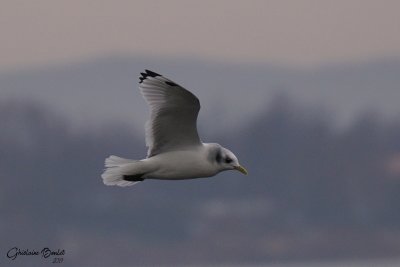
[0,94,400,266]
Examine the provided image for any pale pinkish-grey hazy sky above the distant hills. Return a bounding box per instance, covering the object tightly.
[0,0,400,69]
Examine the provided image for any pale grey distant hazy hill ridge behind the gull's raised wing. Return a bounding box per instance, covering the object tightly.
[0,57,400,136]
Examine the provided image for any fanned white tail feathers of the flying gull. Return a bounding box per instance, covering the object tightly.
[101,156,139,186]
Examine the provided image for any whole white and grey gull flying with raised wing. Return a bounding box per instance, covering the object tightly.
[101,70,247,186]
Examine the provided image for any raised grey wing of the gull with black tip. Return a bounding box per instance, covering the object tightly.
[139,70,201,157]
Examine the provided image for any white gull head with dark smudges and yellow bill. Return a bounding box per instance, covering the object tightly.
[210,144,247,175]
